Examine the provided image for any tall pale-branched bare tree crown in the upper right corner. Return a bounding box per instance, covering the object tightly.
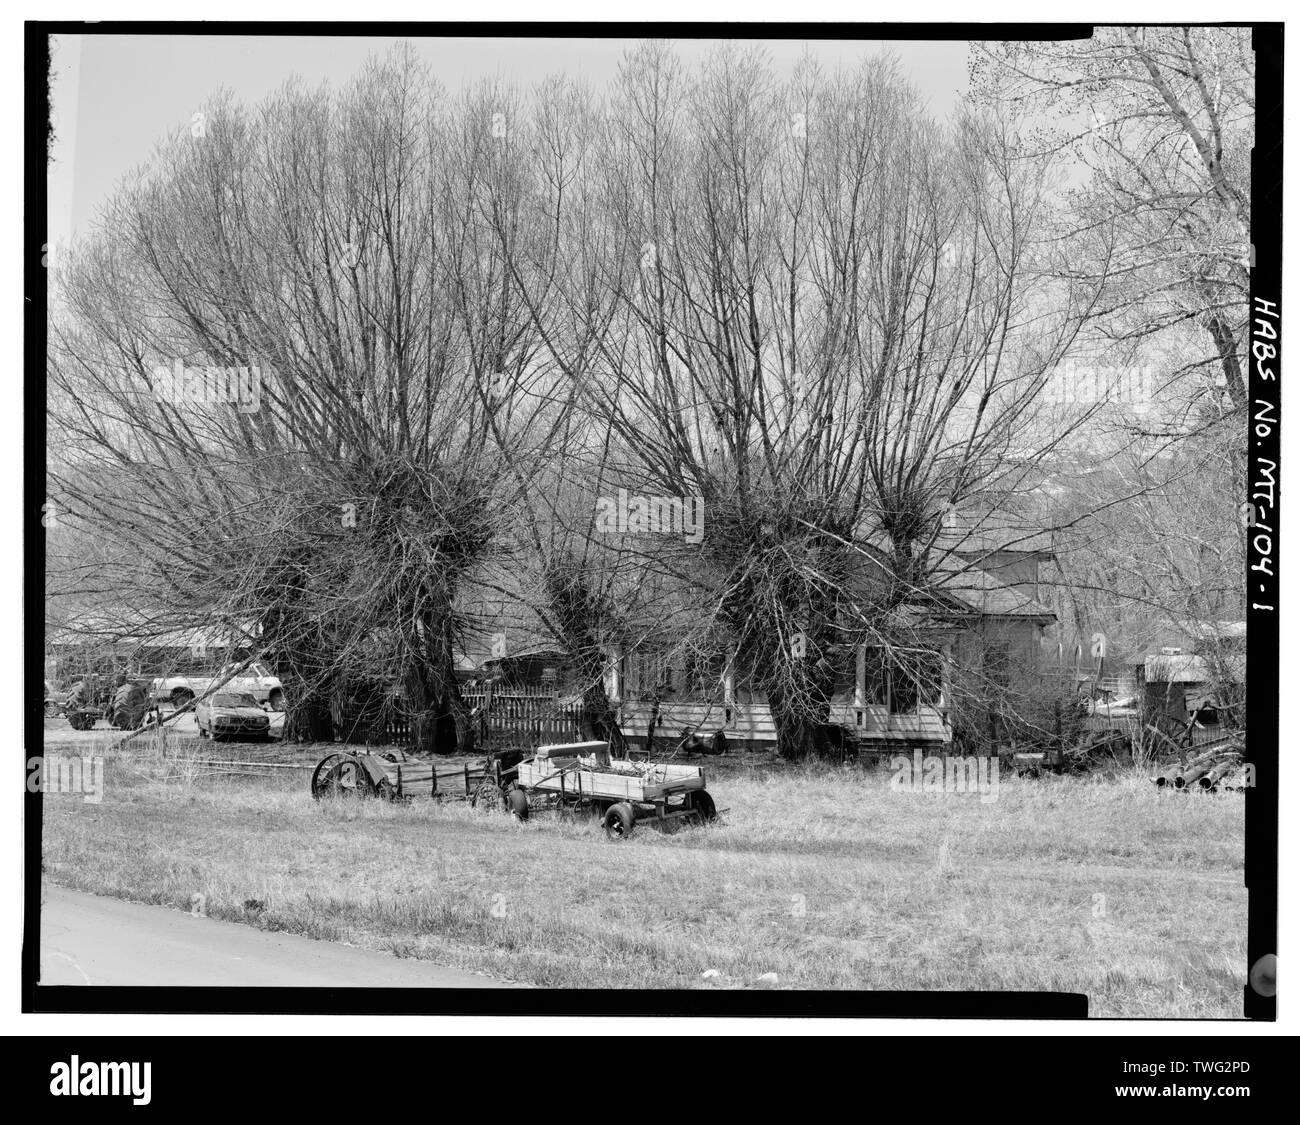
[971,27,1255,412]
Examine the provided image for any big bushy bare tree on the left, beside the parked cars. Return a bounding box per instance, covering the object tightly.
[49,48,559,748]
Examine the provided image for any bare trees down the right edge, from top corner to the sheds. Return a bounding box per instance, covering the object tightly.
[971,27,1255,707]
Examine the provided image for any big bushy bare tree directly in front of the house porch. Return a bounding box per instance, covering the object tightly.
[512,44,1095,757]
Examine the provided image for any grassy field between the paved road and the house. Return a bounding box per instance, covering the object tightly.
[35,743,1245,1017]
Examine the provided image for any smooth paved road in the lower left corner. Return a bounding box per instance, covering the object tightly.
[40,884,511,988]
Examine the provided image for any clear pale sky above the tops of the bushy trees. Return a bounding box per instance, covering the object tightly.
[49,35,966,255]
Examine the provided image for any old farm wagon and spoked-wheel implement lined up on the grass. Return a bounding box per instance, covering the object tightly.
[312,743,718,840]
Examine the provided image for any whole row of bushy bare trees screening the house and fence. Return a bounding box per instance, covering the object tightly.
[49,32,1240,756]
